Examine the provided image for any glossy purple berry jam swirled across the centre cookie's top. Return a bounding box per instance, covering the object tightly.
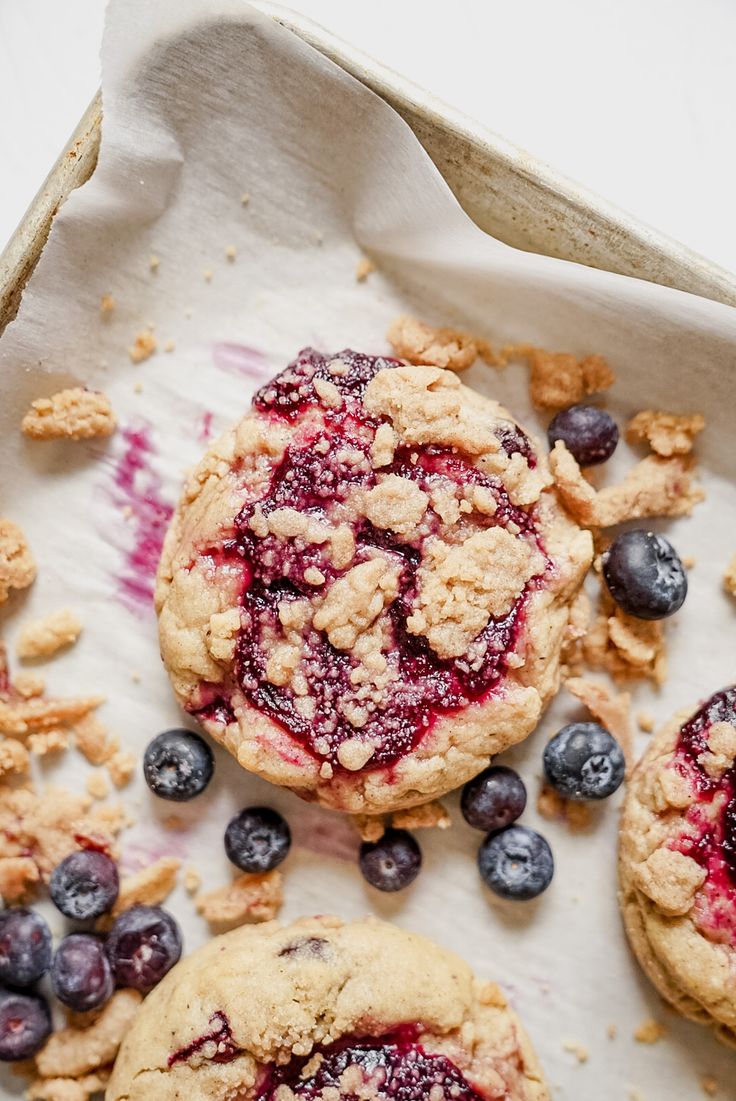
[197,349,549,771]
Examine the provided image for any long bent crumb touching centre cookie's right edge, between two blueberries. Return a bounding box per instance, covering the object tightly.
[550,440,705,527]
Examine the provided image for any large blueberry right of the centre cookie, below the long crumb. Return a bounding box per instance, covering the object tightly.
[603,528,688,619]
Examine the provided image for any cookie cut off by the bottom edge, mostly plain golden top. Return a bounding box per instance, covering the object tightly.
[106,917,549,1101]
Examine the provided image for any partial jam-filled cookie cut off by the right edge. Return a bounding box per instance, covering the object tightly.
[619,687,736,1044]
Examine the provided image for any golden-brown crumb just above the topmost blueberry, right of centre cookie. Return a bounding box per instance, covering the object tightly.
[500,345,615,410]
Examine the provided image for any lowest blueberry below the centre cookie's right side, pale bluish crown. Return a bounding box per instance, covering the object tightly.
[478,826,554,902]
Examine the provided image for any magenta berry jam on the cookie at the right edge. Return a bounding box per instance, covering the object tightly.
[671,687,736,947]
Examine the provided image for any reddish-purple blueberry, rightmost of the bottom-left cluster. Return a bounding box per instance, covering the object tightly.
[107,906,182,994]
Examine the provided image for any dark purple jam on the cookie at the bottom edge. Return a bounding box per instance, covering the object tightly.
[257,1038,484,1101]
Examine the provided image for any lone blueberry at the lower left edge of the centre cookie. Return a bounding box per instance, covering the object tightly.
[143,730,215,803]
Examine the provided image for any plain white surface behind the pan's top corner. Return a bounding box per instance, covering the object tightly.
[0,0,736,270]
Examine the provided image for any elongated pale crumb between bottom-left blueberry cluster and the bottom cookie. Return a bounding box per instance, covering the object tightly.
[35,990,143,1078]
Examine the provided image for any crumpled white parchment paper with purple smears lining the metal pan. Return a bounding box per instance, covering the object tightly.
[0,0,736,1099]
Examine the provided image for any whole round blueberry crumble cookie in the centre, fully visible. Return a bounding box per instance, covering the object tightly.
[156,349,592,814]
